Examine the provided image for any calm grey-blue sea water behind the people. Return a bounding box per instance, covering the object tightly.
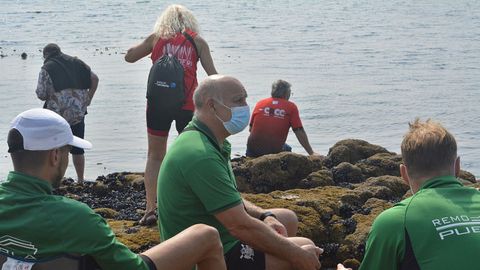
[0,0,480,180]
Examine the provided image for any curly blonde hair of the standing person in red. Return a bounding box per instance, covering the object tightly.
[153,5,199,39]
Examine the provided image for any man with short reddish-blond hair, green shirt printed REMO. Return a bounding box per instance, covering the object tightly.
[338,119,480,270]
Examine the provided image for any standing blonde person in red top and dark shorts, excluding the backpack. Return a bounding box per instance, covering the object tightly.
[125,5,217,225]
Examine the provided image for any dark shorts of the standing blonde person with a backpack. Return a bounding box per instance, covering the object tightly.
[147,106,193,137]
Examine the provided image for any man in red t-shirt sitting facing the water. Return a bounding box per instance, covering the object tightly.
[246,80,315,157]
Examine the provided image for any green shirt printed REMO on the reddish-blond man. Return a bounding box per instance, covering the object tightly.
[360,176,480,270]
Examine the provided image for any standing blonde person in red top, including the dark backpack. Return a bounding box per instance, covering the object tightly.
[125,5,217,225]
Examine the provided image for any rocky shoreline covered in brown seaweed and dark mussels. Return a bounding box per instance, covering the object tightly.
[55,139,480,269]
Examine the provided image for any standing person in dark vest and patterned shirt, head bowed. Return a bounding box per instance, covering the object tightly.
[36,43,98,184]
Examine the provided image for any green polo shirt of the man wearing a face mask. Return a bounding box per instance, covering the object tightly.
[157,117,242,252]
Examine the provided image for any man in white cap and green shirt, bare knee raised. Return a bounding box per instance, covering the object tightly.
[0,109,226,270]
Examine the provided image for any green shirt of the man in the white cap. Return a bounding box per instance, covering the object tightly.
[0,172,148,270]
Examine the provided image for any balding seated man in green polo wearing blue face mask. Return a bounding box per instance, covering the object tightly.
[157,75,321,270]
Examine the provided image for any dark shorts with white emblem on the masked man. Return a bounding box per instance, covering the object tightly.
[225,242,265,270]
